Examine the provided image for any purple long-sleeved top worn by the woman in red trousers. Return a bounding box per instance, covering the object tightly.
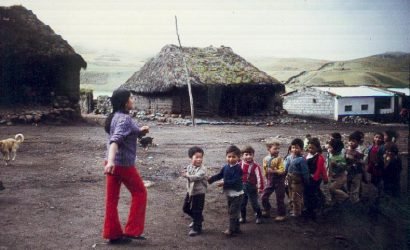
[105,112,140,167]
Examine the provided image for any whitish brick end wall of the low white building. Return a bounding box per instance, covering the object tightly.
[283,88,335,119]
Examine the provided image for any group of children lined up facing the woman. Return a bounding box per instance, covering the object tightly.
[183,130,402,236]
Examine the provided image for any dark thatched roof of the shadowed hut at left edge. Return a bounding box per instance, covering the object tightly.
[0,6,87,68]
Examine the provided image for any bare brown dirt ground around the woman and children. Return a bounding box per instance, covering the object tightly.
[0,120,409,250]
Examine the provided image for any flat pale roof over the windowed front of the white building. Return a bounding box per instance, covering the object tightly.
[313,86,394,97]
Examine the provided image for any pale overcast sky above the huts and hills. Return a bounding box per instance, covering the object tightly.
[0,0,410,60]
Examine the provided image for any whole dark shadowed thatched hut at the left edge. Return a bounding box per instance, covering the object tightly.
[0,6,87,114]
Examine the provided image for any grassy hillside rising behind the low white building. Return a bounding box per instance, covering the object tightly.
[285,53,410,89]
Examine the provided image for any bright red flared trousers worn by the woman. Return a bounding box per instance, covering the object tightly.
[103,166,147,239]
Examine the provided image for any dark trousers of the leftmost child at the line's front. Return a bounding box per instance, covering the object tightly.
[182,193,205,232]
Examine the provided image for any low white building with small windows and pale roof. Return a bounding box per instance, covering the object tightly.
[283,86,395,120]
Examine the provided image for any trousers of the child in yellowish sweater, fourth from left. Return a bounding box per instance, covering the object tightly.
[262,175,286,216]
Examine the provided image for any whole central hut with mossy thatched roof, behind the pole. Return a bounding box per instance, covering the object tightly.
[122,45,285,117]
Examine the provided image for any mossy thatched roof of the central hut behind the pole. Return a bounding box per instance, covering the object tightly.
[122,45,280,93]
